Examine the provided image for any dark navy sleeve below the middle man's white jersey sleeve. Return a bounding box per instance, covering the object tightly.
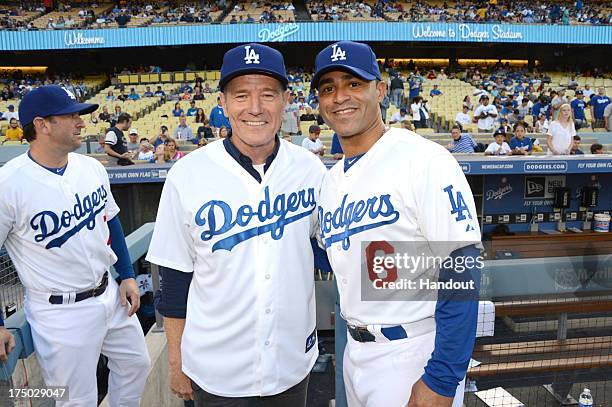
[155,267,193,319]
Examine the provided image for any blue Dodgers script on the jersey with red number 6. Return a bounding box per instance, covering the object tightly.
[319,194,399,250]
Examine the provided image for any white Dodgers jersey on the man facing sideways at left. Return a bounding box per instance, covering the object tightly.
[0,153,119,292]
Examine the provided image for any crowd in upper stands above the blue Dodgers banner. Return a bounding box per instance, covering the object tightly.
[0,0,612,30]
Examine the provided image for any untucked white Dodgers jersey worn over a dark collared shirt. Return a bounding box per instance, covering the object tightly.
[147,140,325,397]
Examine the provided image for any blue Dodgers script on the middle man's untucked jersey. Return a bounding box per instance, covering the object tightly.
[195,187,316,252]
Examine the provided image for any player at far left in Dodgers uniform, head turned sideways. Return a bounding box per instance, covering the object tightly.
[0,85,149,407]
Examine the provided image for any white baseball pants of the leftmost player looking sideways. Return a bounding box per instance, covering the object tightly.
[25,276,150,407]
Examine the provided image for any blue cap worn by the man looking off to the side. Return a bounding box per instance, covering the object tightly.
[19,85,98,126]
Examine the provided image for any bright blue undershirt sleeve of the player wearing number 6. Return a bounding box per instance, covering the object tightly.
[421,245,481,397]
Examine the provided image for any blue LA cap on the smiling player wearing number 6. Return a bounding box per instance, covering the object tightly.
[310,41,380,89]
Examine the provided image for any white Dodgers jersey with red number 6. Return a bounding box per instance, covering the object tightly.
[318,128,480,325]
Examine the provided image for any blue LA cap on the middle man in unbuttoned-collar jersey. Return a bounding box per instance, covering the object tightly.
[219,43,289,91]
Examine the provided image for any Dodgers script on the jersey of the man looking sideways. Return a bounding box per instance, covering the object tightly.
[30,185,108,249]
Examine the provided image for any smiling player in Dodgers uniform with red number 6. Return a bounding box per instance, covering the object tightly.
[311,41,480,407]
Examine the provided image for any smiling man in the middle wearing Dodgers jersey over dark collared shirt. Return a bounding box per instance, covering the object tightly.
[147,44,325,407]
